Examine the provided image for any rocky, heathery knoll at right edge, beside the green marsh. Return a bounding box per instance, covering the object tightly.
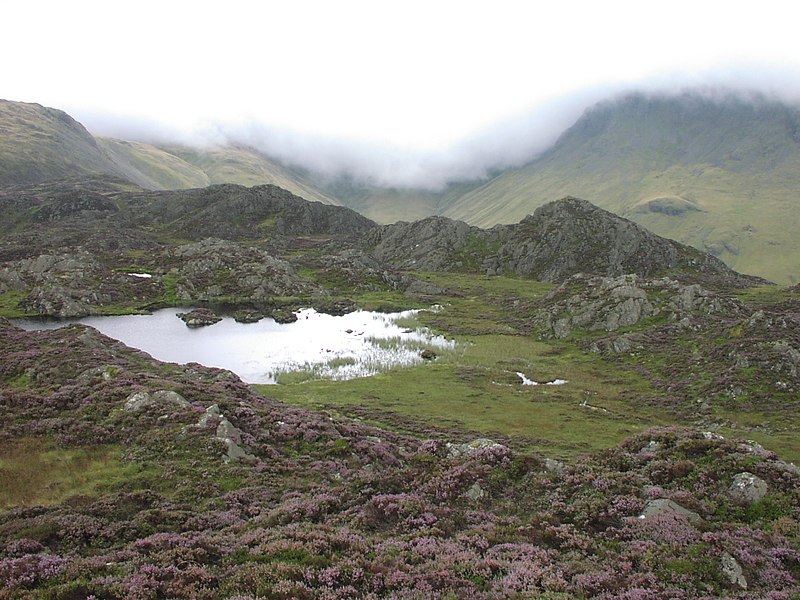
[528,275,800,412]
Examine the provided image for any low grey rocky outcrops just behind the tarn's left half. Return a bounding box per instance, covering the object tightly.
[0,238,327,317]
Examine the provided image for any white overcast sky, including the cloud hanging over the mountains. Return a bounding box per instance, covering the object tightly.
[0,0,800,185]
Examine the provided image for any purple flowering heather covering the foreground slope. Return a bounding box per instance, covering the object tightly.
[0,323,800,600]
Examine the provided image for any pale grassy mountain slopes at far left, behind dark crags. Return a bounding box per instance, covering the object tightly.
[0,100,338,204]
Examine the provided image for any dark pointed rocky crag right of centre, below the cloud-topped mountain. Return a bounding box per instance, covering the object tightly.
[364,198,760,285]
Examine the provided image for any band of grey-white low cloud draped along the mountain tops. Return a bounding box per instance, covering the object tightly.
[72,65,800,190]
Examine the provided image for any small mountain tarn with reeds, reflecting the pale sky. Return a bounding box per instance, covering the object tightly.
[13,308,455,383]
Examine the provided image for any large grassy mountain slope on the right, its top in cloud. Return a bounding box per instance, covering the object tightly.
[445,95,800,283]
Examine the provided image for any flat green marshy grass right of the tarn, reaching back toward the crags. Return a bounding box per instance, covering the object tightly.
[256,273,674,458]
